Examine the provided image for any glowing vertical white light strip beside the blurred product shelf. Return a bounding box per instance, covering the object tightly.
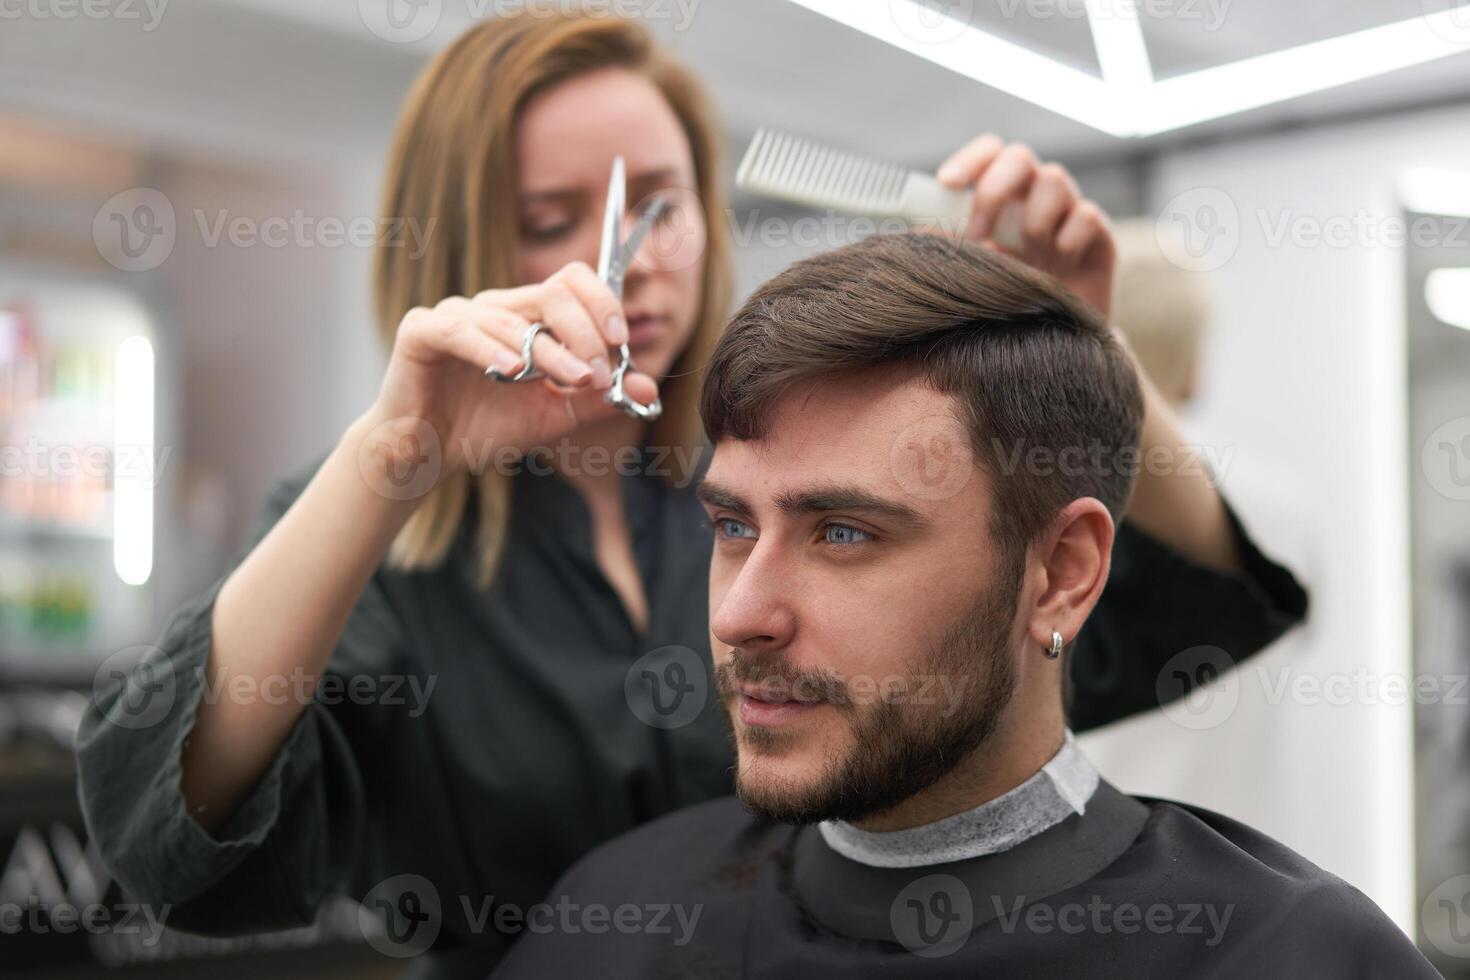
[112,336,154,585]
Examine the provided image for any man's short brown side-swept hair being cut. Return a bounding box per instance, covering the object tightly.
[700,232,1144,561]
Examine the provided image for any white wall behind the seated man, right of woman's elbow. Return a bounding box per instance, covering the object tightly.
[1086,107,1470,929]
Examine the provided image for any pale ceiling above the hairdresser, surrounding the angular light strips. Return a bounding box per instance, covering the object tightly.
[0,0,1470,165]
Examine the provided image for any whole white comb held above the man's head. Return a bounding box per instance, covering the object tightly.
[735,129,1022,248]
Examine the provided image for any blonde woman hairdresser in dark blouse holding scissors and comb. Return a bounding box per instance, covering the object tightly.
[78,15,1305,977]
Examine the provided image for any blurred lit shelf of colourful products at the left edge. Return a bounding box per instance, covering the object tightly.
[0,262,160,686]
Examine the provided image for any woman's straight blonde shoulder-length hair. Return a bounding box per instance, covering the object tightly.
[373,12,734,588]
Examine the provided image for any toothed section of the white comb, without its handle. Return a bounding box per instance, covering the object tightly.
[735,129,908,215]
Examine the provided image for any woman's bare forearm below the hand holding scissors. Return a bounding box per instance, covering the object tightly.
[181,413,422,832]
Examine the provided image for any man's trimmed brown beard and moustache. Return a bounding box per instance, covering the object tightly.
[716,570,1020,824]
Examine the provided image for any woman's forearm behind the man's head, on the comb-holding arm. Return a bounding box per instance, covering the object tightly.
[1127,362,1241,572]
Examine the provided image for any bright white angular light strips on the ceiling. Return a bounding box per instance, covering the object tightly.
[791,0,1470,137]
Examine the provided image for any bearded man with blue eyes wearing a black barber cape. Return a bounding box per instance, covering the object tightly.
[497,235,1438,979]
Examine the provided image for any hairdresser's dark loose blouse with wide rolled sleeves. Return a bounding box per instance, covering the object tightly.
[78,455,1307,977]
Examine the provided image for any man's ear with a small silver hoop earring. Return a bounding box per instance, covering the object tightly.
[1028,497,1114,649]
